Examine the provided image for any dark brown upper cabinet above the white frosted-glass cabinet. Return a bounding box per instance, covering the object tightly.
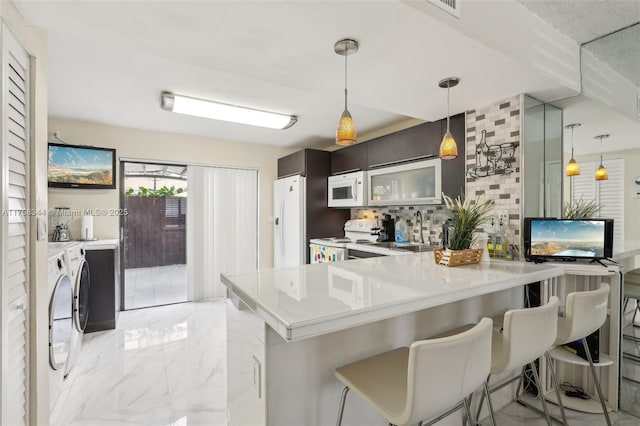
[367,121,441,169]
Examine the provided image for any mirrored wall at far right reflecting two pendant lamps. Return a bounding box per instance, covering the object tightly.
[553,24,640,417]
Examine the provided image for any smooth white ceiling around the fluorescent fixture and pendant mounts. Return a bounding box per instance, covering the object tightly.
[16,0,563,146]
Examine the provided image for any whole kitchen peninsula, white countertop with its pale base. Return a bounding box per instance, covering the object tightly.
[221,252,564,426]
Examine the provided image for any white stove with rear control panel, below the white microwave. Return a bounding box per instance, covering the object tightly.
[309,219,380,263]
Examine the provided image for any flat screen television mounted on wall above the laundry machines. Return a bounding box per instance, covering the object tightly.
[48,143,116,189]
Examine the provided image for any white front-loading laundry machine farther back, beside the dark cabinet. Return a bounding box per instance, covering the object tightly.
[51,242,91,378]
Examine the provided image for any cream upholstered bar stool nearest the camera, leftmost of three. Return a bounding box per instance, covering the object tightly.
[335,318,493,426]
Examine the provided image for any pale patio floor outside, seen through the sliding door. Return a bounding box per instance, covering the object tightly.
[124,265,187,309]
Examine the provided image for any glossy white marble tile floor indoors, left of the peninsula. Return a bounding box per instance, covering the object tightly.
[51,300,226,426]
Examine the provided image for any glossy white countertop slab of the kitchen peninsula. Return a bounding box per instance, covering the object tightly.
[221,252,564,341]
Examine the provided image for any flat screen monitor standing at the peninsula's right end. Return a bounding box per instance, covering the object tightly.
[524,218,613,261]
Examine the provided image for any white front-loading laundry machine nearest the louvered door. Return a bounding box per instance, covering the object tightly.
[48,248,73,409]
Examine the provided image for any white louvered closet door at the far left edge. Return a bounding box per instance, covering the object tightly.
[0,24,29,426]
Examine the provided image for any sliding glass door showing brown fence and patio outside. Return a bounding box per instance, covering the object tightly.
[121,162,188,310]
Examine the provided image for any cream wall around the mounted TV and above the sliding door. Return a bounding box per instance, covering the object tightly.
[49,117,293,267]
